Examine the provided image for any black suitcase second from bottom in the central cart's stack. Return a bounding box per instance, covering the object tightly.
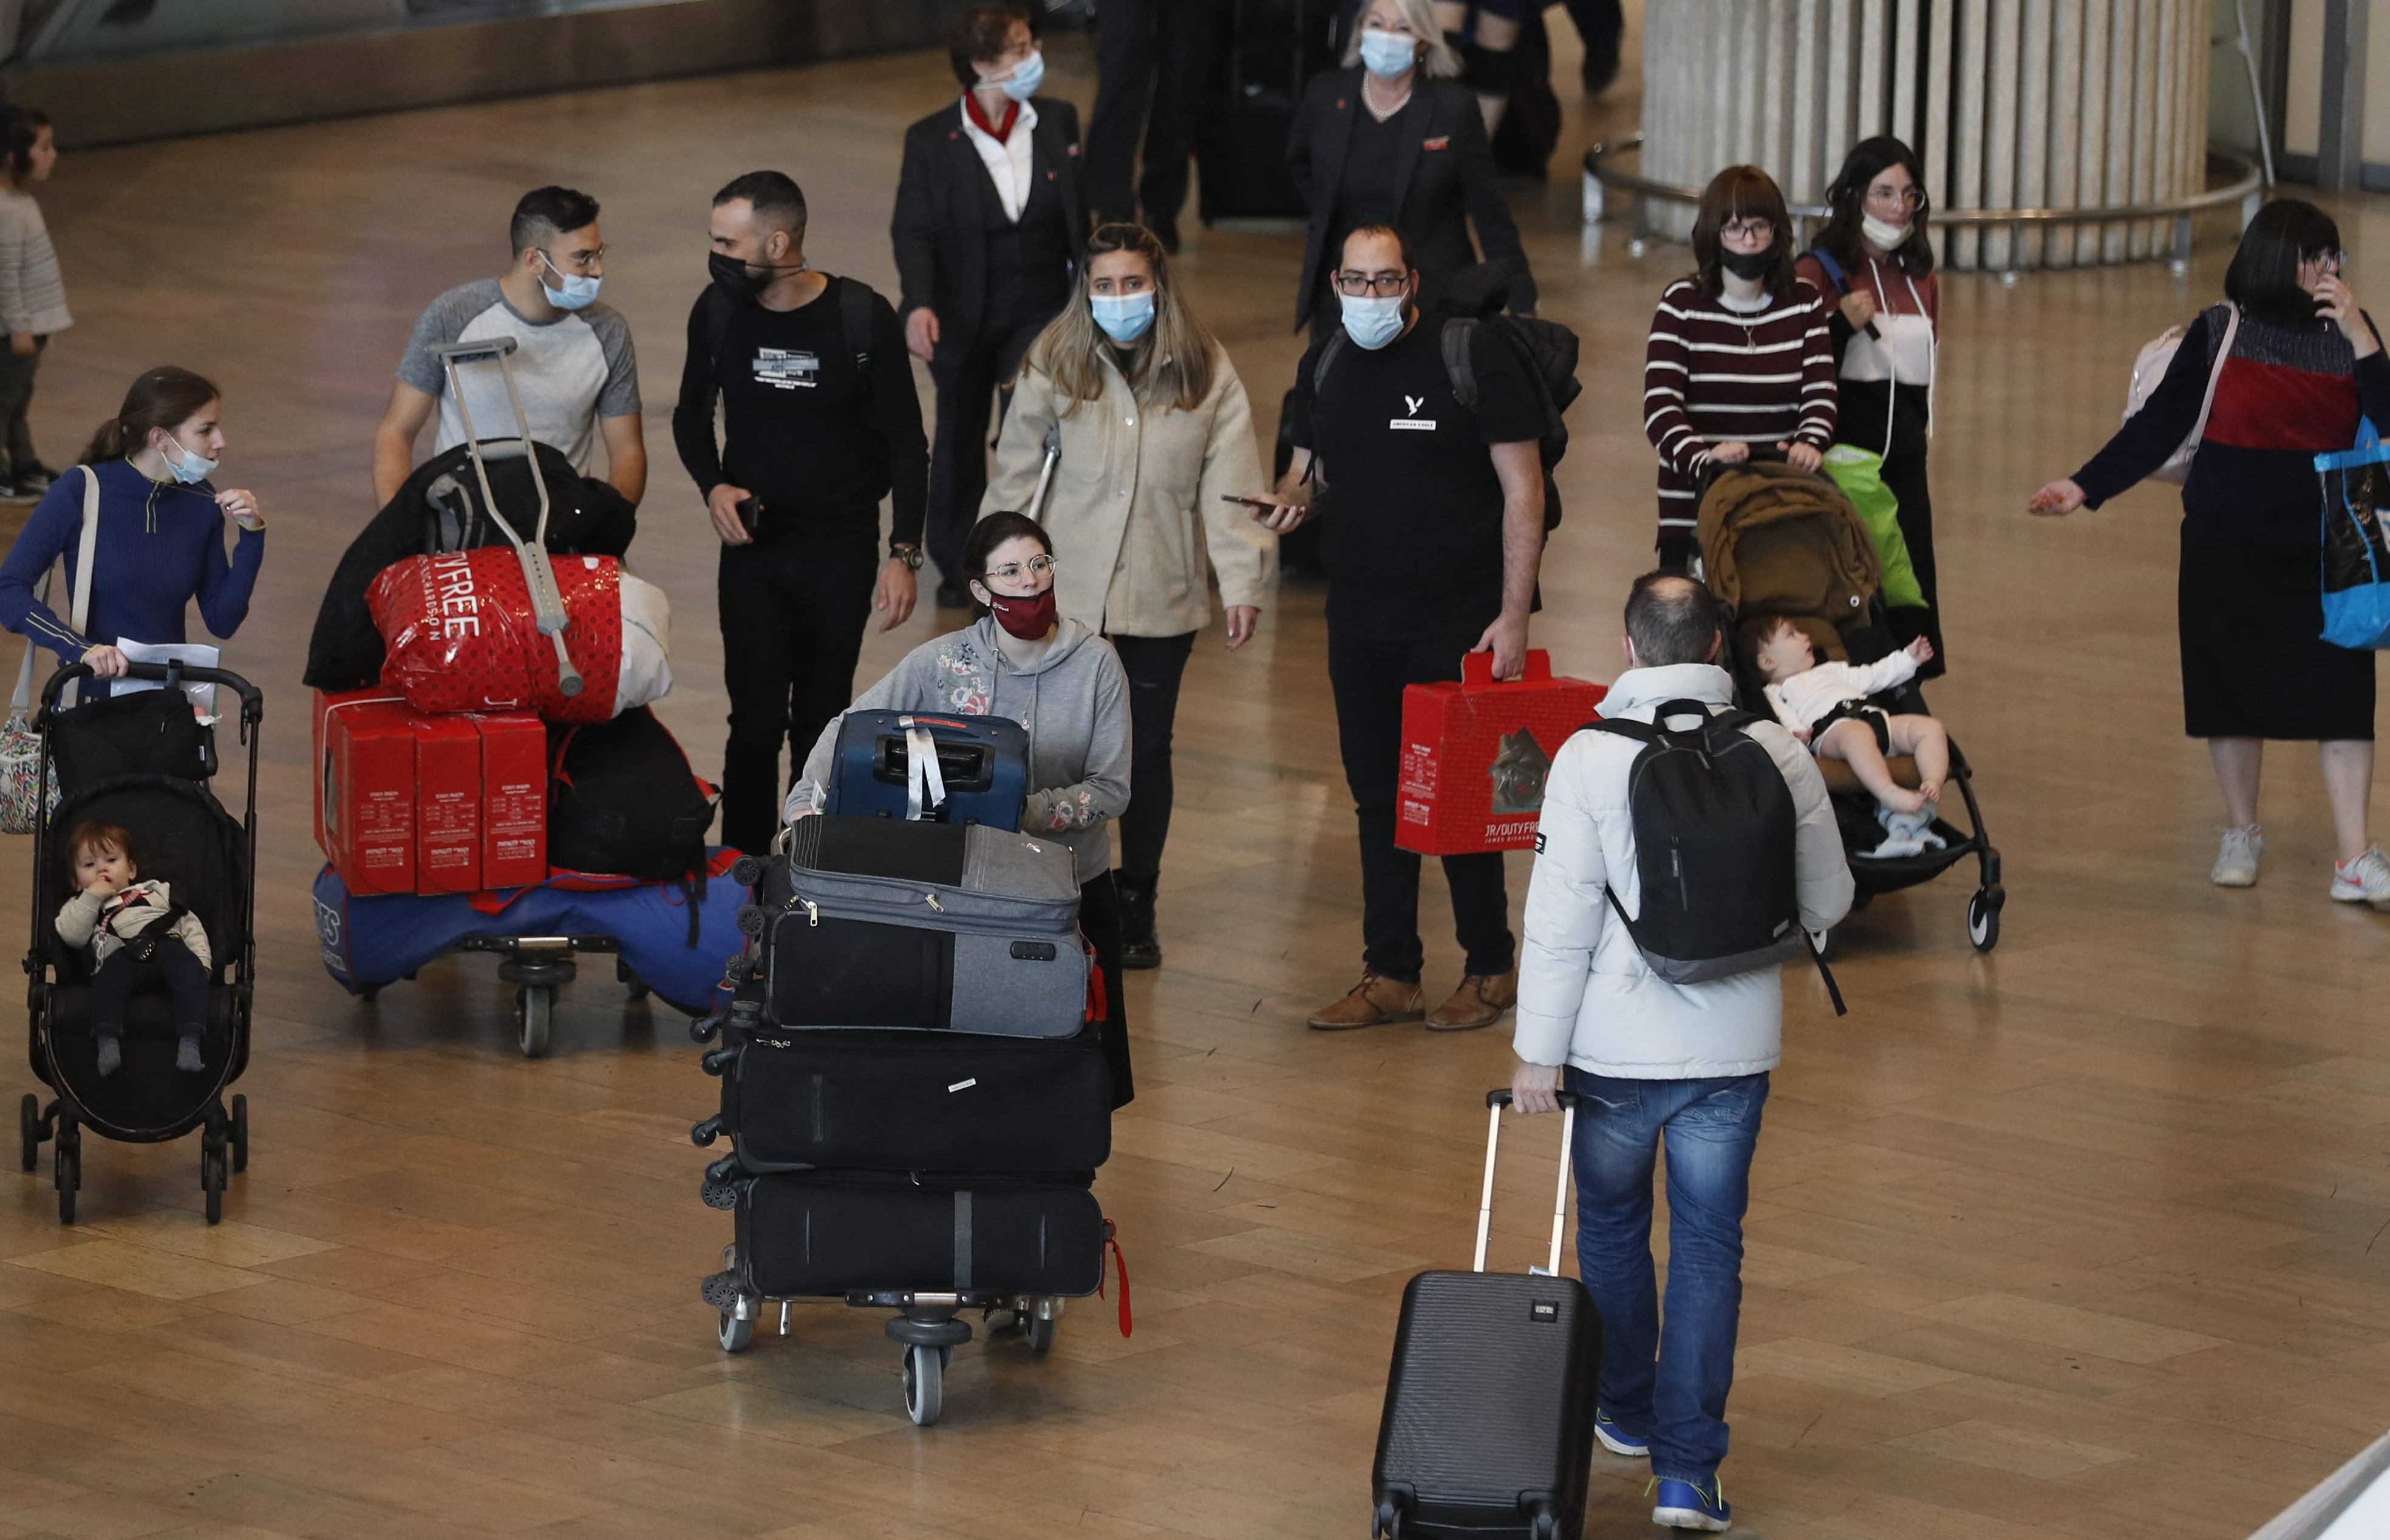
[717,1028,1111,1176]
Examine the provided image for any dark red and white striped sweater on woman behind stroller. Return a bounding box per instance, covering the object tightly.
[1644,278,1836,536]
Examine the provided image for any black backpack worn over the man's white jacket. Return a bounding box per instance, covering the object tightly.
[1587,701,1843,1014]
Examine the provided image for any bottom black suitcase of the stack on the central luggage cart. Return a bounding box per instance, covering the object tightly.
[738,1174,1104,1298]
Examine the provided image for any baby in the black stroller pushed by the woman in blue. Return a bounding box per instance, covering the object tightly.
[57,820,215,1076]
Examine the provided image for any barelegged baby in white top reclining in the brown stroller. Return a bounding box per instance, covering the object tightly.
[1752,615,1950,856]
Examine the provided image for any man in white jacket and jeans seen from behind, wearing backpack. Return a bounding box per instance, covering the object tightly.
[1511,571,1852,1530]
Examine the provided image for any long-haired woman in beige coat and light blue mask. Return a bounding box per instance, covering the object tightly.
[980,225,1279,969]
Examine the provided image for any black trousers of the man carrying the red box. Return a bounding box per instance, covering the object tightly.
[1329,627,1515,983]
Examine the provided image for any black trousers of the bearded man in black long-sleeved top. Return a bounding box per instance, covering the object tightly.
[715,540,879,856]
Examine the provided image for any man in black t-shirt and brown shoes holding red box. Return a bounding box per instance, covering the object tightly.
[1269,225,1544,1031]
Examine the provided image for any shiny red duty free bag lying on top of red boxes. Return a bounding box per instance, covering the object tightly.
[366,545,621,722]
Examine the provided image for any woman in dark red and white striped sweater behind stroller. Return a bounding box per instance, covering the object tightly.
[1644,165,1836,567]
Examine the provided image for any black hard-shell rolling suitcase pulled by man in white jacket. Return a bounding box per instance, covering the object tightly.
[1372,1091,1601,1540]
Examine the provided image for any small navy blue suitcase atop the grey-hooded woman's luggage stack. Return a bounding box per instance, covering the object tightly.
[827,710,1030,830]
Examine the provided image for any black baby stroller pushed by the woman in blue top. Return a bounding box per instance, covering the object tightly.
[17,663,265,1224]
